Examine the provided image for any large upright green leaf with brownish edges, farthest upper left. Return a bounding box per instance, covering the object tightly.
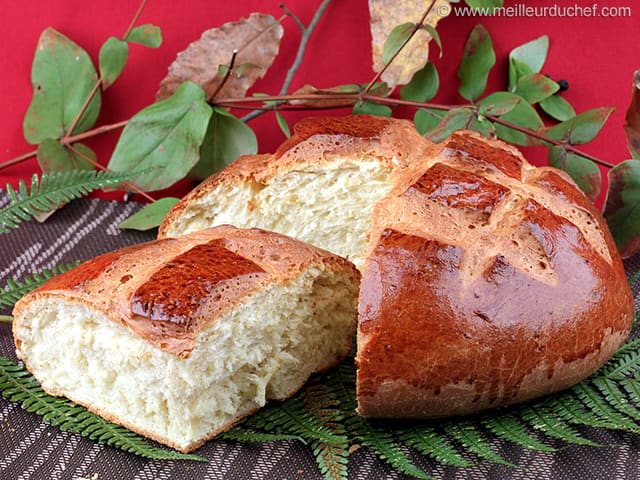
[22,28,101,145]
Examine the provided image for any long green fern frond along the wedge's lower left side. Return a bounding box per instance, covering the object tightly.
[0,356,207,462]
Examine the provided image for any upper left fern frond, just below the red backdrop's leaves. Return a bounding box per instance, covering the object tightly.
[0,170,140,233]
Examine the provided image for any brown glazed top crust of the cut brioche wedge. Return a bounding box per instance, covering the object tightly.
[14,225,359,357]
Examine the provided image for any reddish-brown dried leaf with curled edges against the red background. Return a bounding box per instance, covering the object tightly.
[156,13,283,100]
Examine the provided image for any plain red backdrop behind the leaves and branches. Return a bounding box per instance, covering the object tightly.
[0,0,640,207]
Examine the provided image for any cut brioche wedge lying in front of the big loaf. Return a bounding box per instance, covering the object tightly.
[13,226,359,452]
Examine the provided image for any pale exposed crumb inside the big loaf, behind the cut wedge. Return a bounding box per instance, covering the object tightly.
[166,158,392,269]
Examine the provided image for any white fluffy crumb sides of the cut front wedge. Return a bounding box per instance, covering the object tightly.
[15,267,357,451]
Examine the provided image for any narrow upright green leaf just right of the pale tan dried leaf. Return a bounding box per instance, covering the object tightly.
[458,25,496,102]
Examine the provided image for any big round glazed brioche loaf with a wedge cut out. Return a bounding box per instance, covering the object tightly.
[160,116,633,417]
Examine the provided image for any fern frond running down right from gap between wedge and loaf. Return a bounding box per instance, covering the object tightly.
[326,359,431,479]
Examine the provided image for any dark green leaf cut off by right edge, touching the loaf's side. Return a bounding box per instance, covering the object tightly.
[604,160,640,258]
